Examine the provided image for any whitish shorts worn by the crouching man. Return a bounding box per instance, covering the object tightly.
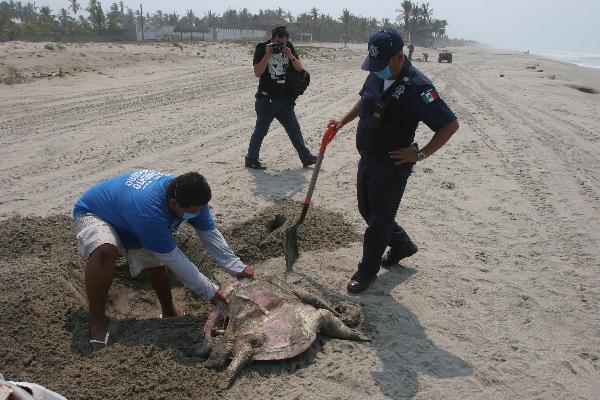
[73,214,162,276]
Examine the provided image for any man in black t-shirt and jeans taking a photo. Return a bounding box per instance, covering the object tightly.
[245,26,317,169]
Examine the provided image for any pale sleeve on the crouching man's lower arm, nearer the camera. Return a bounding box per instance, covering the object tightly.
[153,247,219,300]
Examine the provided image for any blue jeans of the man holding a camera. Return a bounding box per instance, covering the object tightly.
[246,98,312,163]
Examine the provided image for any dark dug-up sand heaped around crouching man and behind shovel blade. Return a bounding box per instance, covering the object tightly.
[0,203,358,399]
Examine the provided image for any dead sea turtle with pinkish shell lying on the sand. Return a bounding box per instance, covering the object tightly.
[200,276,369,388]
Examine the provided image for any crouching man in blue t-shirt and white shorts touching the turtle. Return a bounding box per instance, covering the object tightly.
[73,170,254,348]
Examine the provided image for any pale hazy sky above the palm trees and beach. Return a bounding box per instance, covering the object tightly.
[42,0,600,53]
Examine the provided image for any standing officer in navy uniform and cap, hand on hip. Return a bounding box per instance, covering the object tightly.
[331,29,458,293]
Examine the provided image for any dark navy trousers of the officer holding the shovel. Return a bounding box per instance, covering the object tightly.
[356,158,413,278]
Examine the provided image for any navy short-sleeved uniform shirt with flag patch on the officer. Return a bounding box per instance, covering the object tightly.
[356,59,456,154]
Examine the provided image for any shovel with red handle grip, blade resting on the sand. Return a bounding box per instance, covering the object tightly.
[283,124,336,272]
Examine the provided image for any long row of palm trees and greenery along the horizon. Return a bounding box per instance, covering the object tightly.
[0,0,478,46]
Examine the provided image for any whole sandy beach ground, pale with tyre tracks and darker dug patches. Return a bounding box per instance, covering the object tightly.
[0,43,600,399]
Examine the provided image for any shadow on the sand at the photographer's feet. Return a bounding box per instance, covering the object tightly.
[250,168,307,202]
